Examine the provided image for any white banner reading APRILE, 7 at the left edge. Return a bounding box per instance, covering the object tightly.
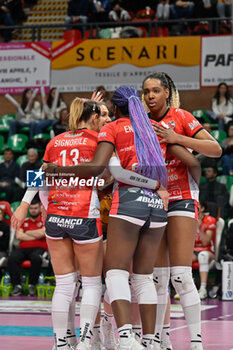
[0,42,51,94]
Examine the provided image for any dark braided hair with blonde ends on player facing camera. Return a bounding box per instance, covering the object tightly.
[142,72,180,108]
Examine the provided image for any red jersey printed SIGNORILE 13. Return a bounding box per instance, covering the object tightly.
[44,129,100,218]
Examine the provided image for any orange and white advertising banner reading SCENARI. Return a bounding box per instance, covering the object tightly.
[51,37,200,92]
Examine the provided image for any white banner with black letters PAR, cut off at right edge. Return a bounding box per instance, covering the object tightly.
[201,35,233,87]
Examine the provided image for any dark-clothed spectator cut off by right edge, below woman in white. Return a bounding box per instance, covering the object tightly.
[221,125,233,176]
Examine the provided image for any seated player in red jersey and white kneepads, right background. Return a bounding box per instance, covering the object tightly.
[193,201,217,300]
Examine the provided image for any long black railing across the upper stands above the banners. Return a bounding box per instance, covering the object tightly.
[0,17,233,41]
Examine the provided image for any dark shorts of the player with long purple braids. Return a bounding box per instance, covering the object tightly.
[109,187,167,228]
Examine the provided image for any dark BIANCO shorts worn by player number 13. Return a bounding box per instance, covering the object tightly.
[45,214,102,244]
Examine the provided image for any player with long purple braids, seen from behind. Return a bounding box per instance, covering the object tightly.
[45,87,206,349]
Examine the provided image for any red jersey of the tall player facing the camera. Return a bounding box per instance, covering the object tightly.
[157,108,203,202]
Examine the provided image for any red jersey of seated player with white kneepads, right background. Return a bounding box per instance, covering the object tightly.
[194,215,217,252]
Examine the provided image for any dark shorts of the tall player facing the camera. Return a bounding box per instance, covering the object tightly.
[167,199,198,220]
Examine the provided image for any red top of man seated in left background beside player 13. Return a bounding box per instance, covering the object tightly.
[19,215,48,250]
